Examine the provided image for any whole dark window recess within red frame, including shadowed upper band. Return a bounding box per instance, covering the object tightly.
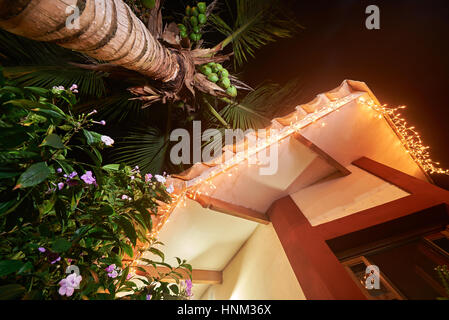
[326,206,449,300]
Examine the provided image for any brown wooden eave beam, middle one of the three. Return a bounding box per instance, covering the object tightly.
[195,195,270,224]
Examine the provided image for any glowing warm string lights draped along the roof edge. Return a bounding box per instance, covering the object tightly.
[130,92,449,267]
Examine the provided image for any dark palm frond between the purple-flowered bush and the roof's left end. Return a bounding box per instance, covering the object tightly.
[112,127,169,174]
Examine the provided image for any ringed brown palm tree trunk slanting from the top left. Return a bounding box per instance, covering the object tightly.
[0,0,181,82]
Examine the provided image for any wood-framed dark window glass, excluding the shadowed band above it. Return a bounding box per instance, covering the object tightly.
[342,232,449,300]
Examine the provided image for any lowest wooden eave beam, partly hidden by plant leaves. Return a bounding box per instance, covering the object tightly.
[136,266,223,284]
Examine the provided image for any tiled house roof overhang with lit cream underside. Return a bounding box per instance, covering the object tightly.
[136,80,426,297]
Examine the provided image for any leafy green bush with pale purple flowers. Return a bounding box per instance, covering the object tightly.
[0,70,191,300]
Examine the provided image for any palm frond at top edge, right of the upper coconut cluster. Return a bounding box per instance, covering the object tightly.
[210,0,302,66]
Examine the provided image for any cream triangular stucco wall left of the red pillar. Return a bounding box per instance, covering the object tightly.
[201,224,305,300]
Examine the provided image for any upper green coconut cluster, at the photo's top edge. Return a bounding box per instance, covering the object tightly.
[178,2,207,42]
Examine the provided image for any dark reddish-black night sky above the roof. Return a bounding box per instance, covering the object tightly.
[243,0,449,189]
